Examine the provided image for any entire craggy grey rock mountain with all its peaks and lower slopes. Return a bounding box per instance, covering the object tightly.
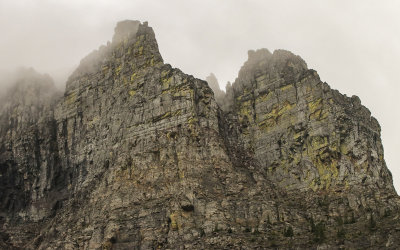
[0,21,400,249]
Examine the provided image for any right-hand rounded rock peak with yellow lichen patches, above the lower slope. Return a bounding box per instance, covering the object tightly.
[223,50,395,193]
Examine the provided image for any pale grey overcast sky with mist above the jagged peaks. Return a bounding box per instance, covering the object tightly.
[0,0,400,190]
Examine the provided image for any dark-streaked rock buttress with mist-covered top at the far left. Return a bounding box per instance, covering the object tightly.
[0,69,60,221]
